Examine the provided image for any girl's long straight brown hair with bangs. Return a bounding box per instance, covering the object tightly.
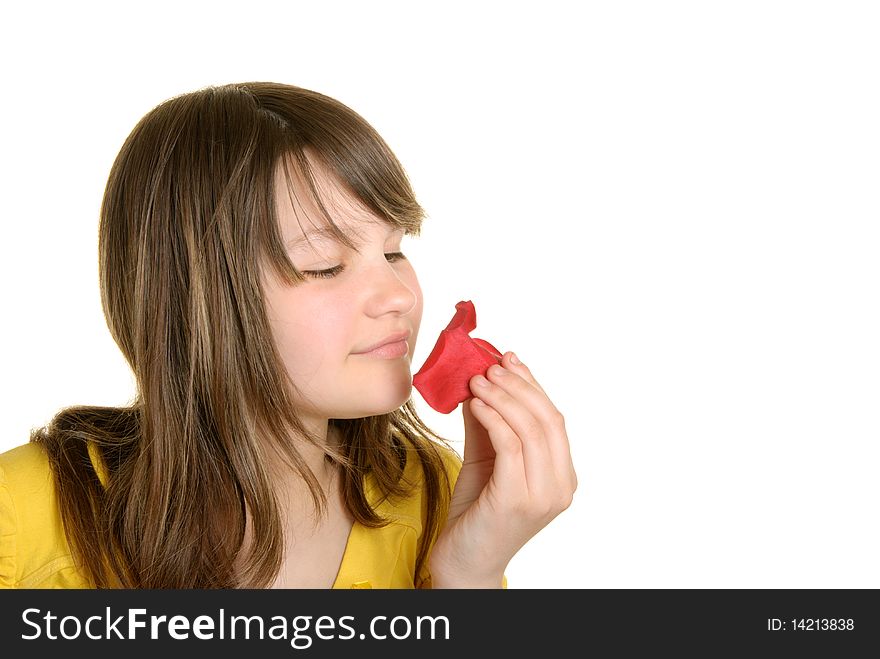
[31,82,449,588]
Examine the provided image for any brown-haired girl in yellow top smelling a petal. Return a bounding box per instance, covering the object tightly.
[0,82,576,588]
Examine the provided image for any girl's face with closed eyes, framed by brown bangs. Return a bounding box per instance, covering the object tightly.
[265,159,422,420]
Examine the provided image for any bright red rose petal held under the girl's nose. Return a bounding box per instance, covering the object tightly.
[413,300,502,414]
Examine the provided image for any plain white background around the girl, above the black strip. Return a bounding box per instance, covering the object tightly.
[0,0,880,588]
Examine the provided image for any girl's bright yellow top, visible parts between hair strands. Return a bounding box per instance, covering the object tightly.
[0,443,492,588]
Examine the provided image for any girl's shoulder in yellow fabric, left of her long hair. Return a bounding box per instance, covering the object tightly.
[0,443,86,588]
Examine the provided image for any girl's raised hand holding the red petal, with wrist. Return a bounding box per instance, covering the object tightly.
[430,352,577,588]
